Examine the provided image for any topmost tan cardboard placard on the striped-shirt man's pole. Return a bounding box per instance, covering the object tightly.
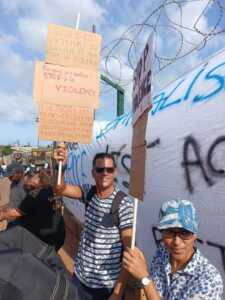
[45,24,101,70]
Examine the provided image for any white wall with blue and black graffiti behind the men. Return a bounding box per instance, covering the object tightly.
[63,49,225,278]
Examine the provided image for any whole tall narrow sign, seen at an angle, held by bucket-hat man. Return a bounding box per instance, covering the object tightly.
[130,34,153,200]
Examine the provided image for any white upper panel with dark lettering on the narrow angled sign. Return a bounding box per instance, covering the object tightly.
[132,34,153,124]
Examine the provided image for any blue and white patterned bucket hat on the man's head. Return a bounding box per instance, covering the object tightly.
[157,199,198,234]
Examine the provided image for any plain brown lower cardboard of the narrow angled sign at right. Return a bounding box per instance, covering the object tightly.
[129,112,148,200]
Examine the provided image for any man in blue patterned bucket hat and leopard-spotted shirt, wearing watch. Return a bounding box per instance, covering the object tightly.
[123,200,223,300]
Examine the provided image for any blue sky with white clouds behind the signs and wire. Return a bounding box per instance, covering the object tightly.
[0,0,225,145]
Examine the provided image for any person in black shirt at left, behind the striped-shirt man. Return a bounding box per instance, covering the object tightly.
[0,171,65,250]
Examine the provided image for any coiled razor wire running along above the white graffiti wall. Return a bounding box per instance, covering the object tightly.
[102,0,225,93]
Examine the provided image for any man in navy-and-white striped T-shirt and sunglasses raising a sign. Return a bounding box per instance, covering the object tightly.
[54,145,133,300]
